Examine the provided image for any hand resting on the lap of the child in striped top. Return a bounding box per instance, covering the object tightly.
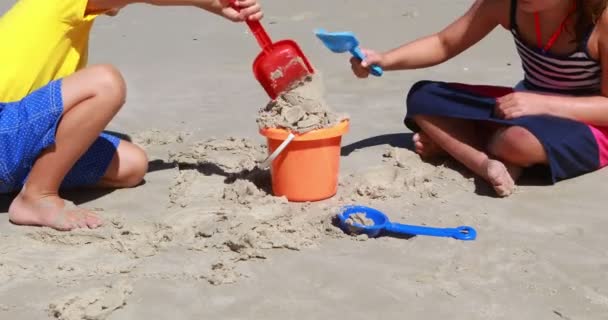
[494,92,552,120]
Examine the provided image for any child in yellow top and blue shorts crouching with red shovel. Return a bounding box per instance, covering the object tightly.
[0,0,262,230]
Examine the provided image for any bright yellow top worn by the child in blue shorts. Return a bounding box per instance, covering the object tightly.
[0,0,97,102]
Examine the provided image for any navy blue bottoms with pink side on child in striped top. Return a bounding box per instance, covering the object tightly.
[404,80,608,183]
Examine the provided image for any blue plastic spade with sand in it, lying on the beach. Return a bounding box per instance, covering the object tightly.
[338,206,477,240]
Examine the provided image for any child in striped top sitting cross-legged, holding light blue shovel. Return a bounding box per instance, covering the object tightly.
[351,0,608,196]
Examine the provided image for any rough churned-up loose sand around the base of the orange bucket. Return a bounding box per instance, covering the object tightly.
[0,136,474,319]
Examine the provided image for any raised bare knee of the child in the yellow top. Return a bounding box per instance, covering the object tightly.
[90,64,127,106]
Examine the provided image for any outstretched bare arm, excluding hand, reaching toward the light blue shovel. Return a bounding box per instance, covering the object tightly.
[378,0,502,70]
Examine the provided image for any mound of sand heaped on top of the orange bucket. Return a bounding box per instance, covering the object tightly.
[257,74,348,134]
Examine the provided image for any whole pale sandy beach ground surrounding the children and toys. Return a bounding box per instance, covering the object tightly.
[0,0,608,320]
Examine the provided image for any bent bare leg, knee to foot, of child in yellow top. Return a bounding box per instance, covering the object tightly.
[9,66,126,230]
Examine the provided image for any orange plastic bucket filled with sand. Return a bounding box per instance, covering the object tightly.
[260,120,349,202]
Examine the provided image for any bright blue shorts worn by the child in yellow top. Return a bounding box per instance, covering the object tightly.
[0,80,120,193]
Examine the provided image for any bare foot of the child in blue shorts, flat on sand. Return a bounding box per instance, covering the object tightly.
[8,192,102,231]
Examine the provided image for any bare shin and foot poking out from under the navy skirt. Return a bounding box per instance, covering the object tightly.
[414,116,520,196]
